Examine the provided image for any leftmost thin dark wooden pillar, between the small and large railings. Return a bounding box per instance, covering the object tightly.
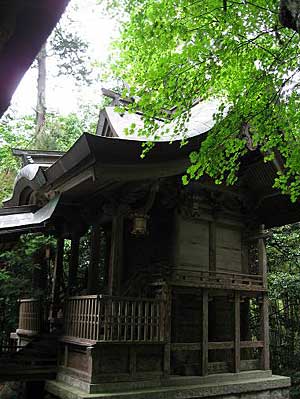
[50,237,64,319]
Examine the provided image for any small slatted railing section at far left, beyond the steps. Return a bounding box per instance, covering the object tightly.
[18,298,43,333]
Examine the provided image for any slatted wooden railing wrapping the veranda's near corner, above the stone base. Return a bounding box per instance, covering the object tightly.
[64,295,165,343]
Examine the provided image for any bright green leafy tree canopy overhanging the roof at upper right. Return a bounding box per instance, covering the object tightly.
[108,0,300,201]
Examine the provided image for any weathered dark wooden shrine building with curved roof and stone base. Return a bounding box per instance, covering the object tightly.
[0,95,292,399]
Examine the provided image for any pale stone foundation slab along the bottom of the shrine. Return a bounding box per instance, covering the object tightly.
[46,371,290,399]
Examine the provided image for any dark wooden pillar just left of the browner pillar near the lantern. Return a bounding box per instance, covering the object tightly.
[87,225,102,295]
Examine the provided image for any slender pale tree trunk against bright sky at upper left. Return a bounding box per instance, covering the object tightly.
[35,44,47,137]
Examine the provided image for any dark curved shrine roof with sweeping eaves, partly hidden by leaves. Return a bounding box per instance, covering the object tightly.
[5,111,300,227]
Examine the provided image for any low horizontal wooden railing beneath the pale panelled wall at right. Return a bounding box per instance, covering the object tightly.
[172,268,266,291]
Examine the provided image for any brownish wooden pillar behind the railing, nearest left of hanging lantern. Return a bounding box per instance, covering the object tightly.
[108,211,124,295]
